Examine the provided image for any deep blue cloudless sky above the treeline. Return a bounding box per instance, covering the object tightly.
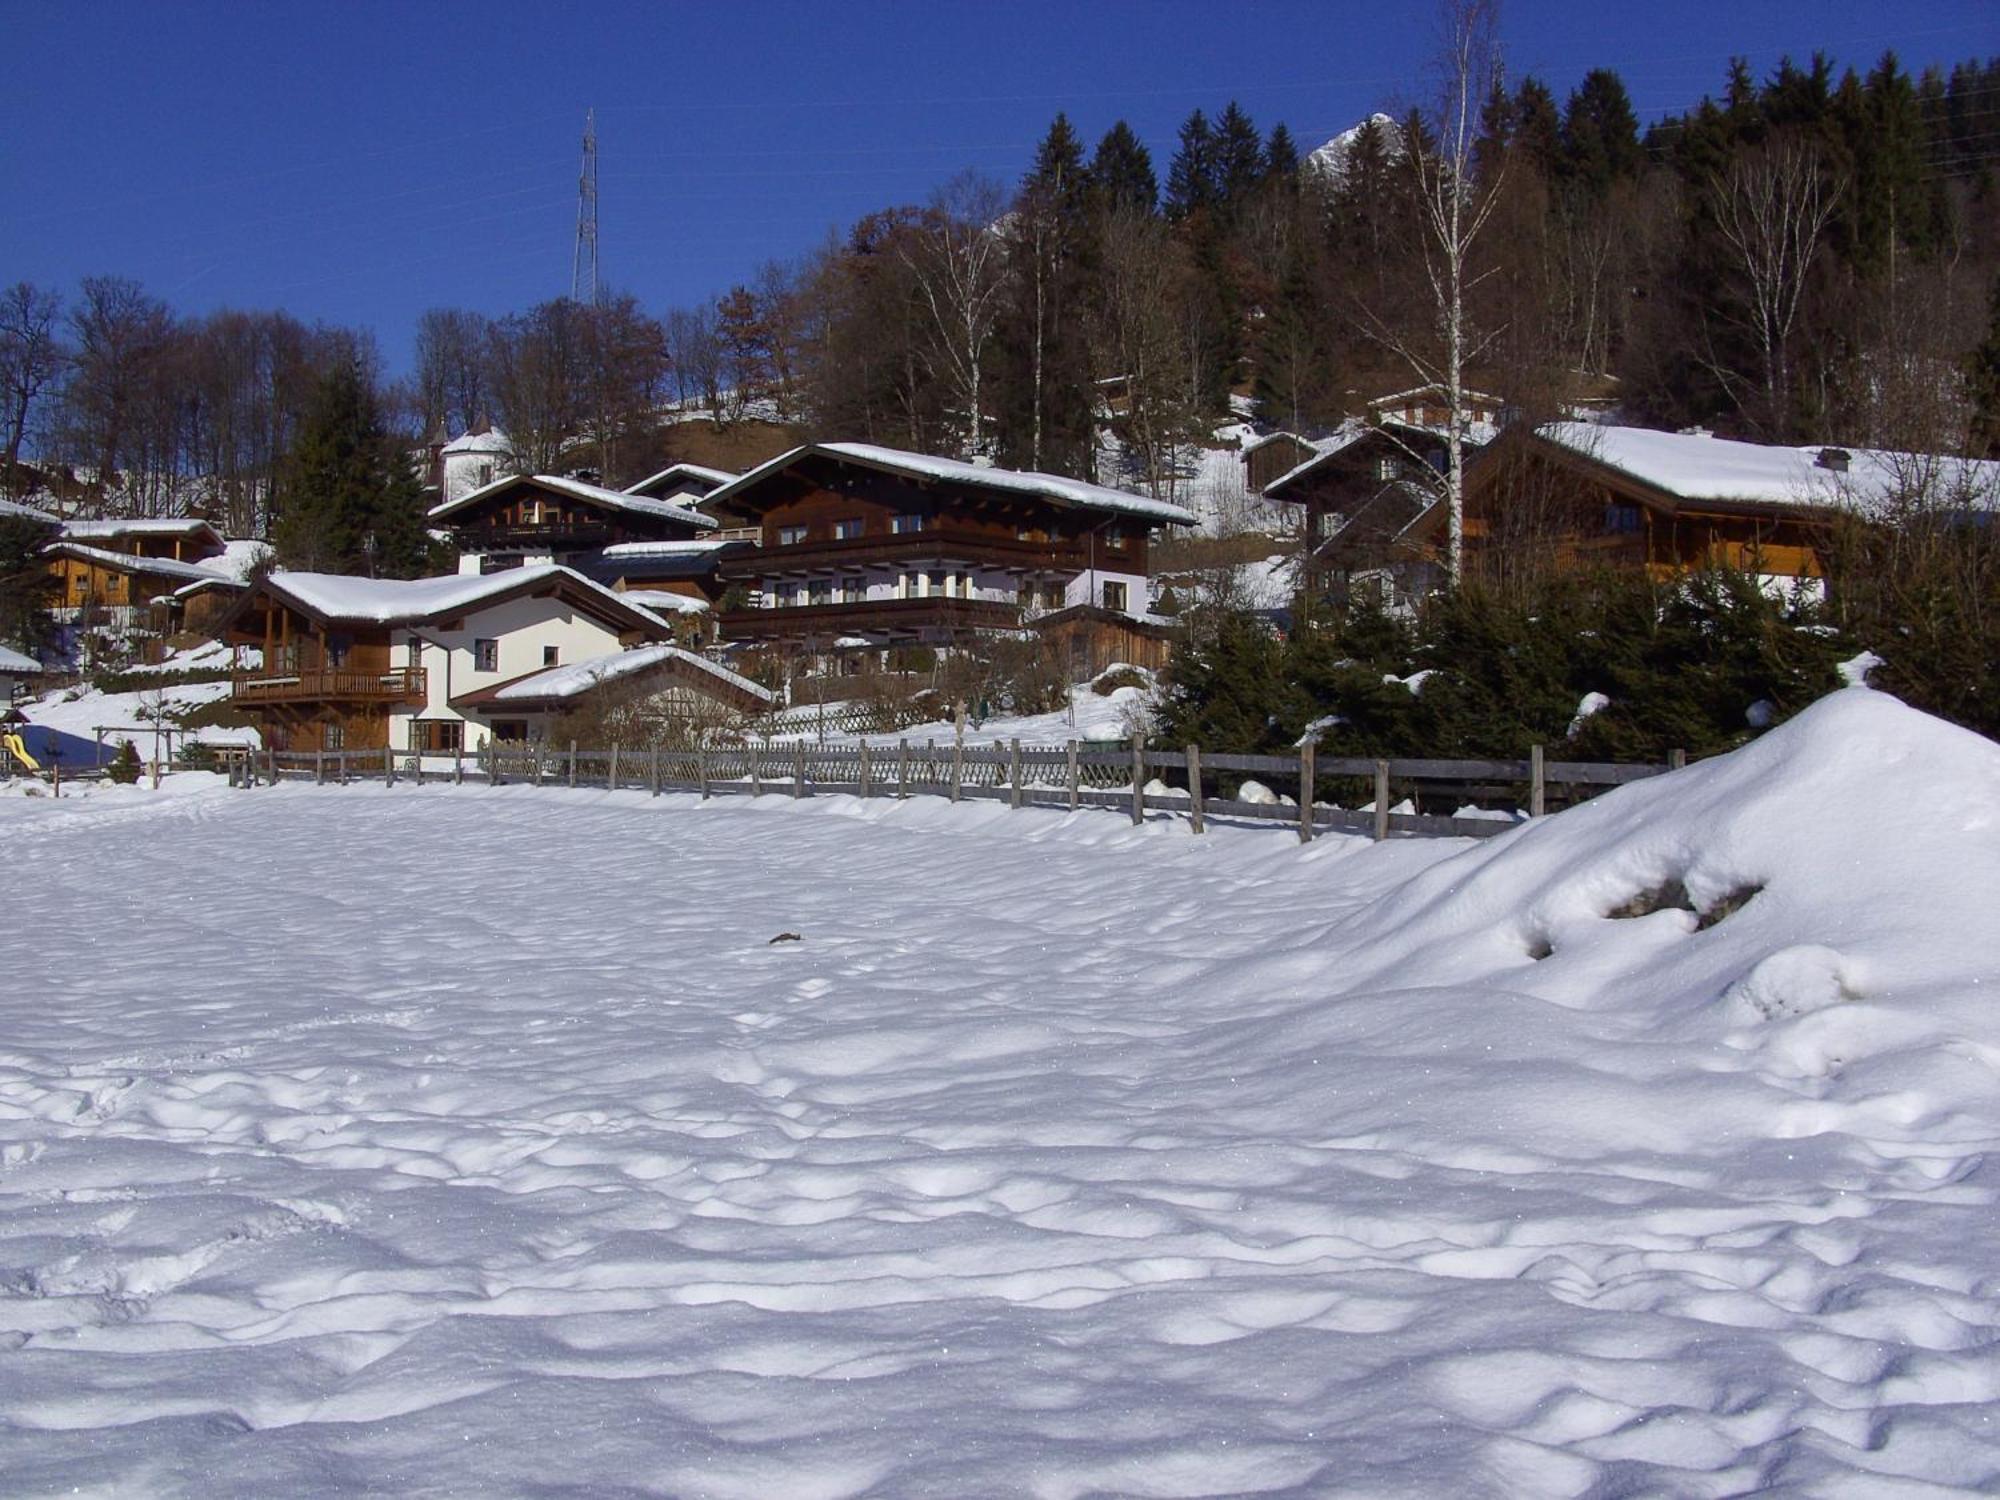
[0,0,2000,368]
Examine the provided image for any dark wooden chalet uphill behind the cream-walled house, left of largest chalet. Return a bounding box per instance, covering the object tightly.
[430,474,716,572]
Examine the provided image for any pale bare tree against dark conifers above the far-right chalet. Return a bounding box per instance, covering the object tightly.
[1708,140,1842,438]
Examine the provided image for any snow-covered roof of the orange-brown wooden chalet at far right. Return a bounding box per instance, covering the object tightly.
[1538,422,2000,514]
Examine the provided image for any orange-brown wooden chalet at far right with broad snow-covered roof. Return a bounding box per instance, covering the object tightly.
[1456,422,2000,584]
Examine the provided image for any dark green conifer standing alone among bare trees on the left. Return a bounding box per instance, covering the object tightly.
[272,360,428,578]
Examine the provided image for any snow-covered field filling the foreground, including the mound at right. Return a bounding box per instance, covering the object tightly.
[0,688,2000,1496]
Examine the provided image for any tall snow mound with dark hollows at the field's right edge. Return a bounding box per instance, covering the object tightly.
[1342,688,2000,1048]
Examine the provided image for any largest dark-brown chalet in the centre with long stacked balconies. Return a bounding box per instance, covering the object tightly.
[708,442,1194,652]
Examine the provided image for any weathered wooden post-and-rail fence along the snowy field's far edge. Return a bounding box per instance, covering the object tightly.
[228,740,1682,840]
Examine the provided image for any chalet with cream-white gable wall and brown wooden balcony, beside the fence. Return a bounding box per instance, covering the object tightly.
[224,566,672,754]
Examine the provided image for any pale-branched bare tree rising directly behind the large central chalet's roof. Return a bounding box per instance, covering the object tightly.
[900,170,1006,456]
